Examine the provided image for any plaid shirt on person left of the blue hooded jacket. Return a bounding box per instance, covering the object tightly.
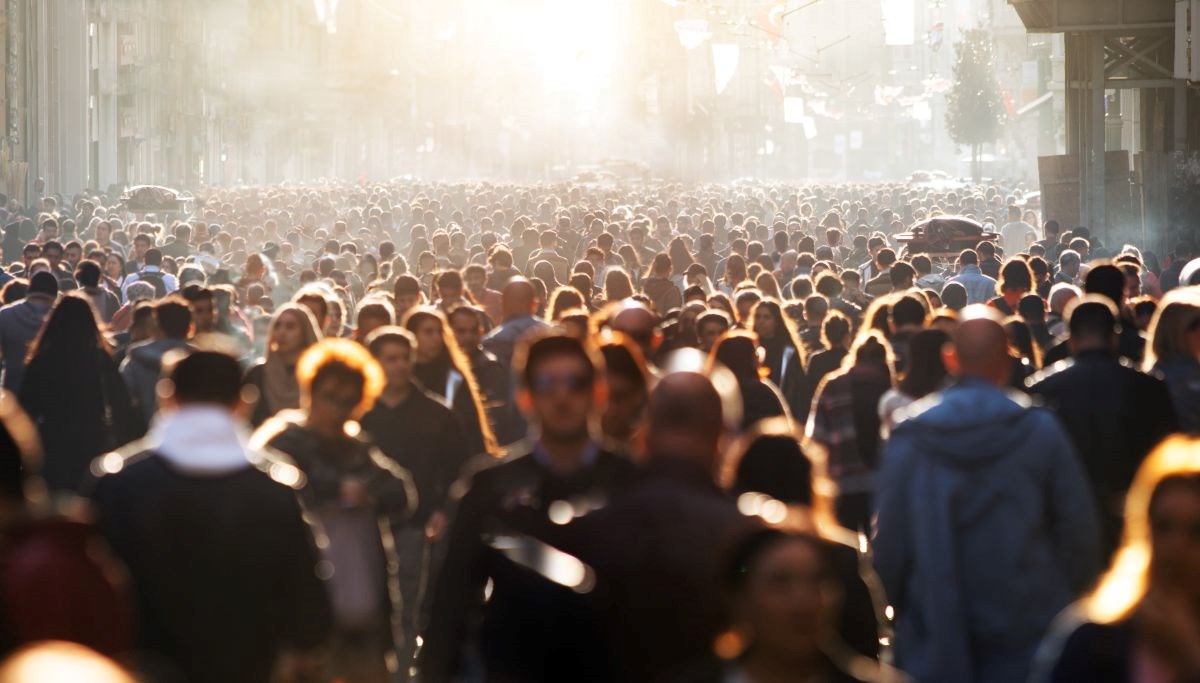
[806,365,892,493]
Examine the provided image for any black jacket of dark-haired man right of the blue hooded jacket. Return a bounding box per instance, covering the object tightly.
[1026,351,1178,553]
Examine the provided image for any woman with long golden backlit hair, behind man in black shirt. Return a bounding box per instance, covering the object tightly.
[404,306,499,455]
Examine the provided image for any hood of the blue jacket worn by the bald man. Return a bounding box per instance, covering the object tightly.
[893,378,1032,469]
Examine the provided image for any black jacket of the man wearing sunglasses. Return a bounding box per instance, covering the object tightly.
[420,448,632,681]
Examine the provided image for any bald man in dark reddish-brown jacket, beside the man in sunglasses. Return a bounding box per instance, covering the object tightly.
[532,372,758,681]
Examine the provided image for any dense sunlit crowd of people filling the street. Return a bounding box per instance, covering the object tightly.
[0,181,1200,683]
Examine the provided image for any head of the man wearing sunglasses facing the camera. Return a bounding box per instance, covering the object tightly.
[512,332,606,441]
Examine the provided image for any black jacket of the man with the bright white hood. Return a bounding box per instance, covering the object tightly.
[92,451,330,683]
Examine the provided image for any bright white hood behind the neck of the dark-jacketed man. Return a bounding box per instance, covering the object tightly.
[143,405,252,475]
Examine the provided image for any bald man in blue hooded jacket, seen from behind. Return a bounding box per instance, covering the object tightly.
[875,305,1099,683]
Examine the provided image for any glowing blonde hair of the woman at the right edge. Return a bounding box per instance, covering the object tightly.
[1082,436,1200,624]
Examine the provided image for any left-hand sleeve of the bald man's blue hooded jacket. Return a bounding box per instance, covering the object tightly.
[872,431,914,610]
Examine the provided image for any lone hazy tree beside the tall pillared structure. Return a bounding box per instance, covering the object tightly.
[946,29,1004,182]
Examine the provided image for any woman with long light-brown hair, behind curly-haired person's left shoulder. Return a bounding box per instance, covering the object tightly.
[246,304,322,427]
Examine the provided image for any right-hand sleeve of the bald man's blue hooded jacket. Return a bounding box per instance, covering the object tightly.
[1034,411,1100,594]
